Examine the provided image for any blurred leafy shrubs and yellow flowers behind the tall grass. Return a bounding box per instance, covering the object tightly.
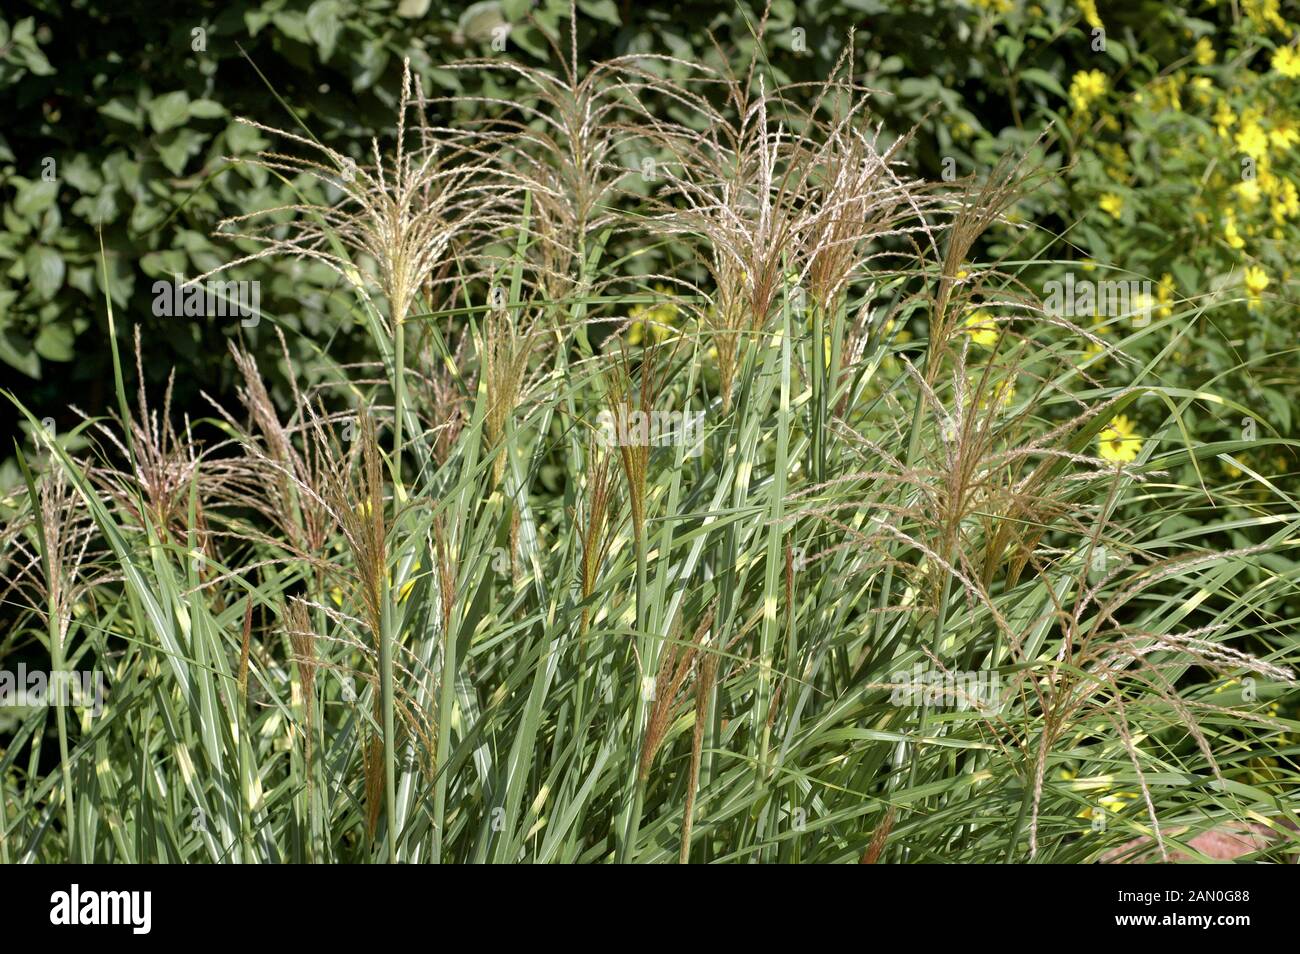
[0,0,1300,501]
